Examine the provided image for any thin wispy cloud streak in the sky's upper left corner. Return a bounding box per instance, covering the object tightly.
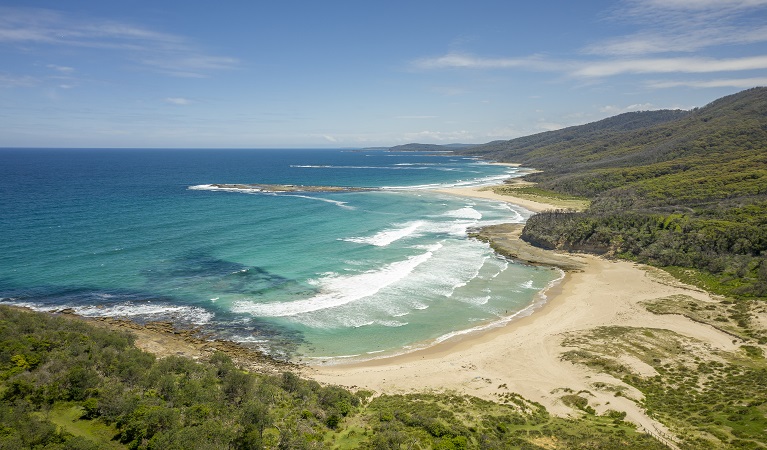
[0,7,239,77]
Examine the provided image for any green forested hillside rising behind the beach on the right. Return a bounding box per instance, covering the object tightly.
[465,88,767,298]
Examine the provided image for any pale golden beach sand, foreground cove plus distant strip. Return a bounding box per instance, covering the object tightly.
[302,184,737,440]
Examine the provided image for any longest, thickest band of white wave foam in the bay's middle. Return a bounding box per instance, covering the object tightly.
[232,243,442,317]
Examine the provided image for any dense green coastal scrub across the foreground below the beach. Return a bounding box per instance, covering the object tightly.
[0,307,662,449]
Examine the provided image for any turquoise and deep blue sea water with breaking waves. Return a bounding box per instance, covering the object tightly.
[0,149,560,360]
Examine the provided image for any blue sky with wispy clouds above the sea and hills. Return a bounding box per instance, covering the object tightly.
[0,0,767,148]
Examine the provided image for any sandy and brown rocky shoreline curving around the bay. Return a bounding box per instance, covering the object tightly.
[24,181,738,434]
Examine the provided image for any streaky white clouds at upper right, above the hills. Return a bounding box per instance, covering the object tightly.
[411,0,767,88]
